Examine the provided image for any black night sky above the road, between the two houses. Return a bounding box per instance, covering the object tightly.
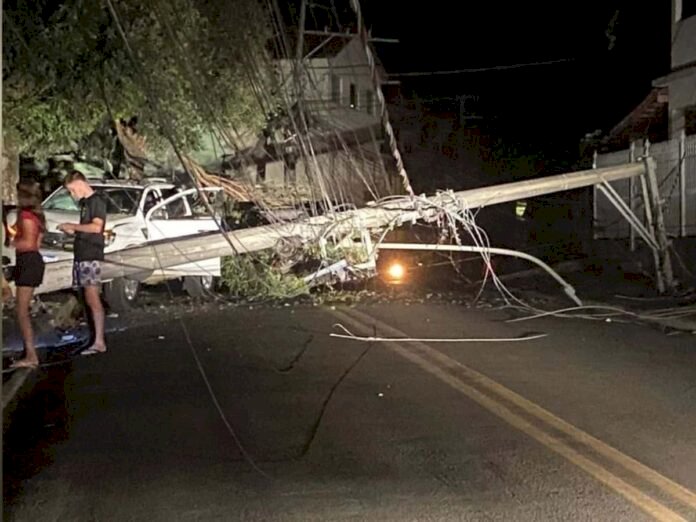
[362,0,670,149]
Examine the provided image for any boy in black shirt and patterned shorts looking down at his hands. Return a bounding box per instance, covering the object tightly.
[58,171,106,355]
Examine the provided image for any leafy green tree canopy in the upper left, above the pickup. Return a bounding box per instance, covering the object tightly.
[3,0,269,155]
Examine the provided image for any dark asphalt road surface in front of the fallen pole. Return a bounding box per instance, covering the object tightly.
[3,298,696,522]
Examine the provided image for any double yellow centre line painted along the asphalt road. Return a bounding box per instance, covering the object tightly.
[331,309,696,522]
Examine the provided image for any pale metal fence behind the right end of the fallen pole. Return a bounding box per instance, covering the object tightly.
[593,134,696,241]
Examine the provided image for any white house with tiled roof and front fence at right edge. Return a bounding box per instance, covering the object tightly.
[594,0,696,240]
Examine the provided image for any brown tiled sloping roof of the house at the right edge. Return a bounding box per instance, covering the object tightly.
[601,87,669,148]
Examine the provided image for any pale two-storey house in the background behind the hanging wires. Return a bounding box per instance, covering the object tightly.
[245,31,399,204]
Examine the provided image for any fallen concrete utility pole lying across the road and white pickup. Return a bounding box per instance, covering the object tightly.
[28,158,672,293]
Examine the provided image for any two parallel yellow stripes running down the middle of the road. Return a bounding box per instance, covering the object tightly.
[332,310,693,521]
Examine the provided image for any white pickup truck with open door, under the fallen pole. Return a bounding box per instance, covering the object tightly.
[3,179,223,310]
